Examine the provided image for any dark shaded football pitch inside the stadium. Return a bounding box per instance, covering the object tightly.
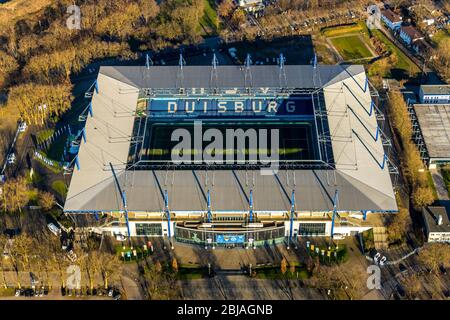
[141,121,317,162]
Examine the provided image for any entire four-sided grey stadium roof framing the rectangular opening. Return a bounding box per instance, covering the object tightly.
[64,65,397,212]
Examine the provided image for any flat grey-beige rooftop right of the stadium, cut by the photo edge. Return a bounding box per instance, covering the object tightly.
[414,104,450,159]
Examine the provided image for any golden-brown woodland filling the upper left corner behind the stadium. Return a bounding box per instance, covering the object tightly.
[0,0,210,129]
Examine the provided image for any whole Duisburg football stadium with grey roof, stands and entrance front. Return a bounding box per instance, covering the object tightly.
[64,58,398,247]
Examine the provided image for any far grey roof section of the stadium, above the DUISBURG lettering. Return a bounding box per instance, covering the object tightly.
[100,65,364,88]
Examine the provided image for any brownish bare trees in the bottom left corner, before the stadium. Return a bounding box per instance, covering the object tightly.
[0,232,122,293]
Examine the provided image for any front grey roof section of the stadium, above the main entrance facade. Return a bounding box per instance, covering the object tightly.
[66,170,395,212]
